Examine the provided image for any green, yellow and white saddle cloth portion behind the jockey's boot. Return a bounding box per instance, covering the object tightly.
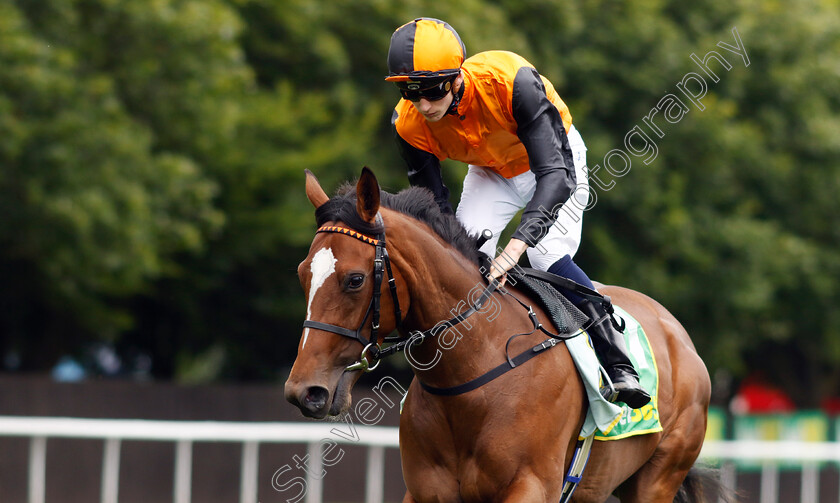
[595,306,662,440]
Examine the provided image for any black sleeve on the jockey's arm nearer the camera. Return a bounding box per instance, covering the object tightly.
[512,67,577,246]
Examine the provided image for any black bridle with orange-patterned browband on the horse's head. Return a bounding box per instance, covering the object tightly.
[303,218,402,372]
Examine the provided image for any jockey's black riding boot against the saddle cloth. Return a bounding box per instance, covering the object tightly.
[578,301,650,409]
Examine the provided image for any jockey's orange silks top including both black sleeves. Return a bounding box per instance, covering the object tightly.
[392,51,576,246]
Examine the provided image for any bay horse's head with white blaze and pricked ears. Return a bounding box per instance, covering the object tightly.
[285,168,400,419]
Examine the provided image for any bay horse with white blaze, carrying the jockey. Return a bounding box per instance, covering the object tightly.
[285,168,722,503]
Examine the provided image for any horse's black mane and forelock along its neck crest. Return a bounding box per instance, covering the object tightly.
[315,183,482,265]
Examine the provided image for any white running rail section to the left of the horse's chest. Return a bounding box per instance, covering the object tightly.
[0,416,399,503]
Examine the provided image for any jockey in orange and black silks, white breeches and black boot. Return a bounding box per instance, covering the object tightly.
[385,18,650,409]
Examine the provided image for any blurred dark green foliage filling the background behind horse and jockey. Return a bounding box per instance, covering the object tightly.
[0,0,840,406]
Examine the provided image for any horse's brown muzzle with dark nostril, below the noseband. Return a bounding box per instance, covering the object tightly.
[285,369,361,419]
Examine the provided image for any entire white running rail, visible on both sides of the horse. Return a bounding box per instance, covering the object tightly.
[0,416,840,503]
